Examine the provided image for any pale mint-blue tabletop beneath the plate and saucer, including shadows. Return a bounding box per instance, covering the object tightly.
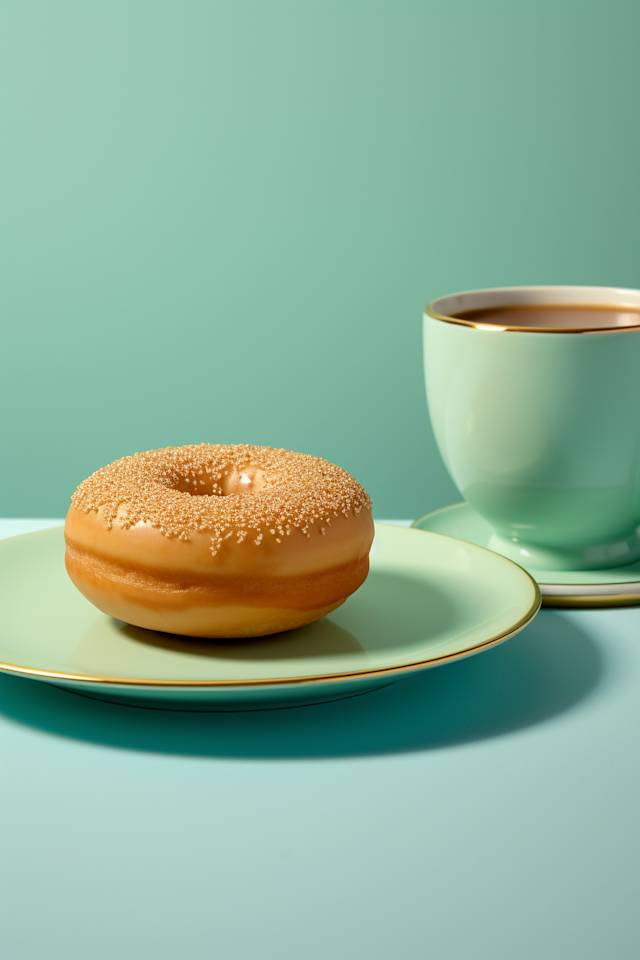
[0,520,640,960]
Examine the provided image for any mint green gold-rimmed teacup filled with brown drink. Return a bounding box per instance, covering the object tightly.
[424,287,640,570]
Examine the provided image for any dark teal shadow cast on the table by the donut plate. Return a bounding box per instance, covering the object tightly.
[0,611,604,759]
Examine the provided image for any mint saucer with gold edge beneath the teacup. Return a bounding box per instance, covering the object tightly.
[412,503,640,607]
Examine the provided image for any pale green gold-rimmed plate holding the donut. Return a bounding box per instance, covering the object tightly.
[0,524,540,711]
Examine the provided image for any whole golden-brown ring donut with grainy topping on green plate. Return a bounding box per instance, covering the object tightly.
[65,443,373,638]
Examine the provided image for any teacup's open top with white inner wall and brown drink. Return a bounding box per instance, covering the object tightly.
[425,286,640,333]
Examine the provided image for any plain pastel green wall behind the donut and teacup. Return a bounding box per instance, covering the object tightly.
[0,0,640,517]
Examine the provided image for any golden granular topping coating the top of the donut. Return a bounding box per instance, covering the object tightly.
[71,443,371,556]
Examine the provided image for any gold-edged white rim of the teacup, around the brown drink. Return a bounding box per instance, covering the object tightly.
[425,286,640,333]
